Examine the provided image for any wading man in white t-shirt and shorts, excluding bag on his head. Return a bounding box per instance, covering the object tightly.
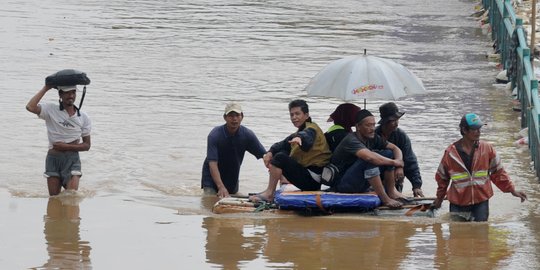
[26,85,92,196]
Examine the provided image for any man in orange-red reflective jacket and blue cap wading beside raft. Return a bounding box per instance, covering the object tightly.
[433,113,527,221]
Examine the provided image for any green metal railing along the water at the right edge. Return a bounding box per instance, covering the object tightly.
[482,0,540,177]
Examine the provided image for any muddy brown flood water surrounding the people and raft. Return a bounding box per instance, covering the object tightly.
[0,0,540,269]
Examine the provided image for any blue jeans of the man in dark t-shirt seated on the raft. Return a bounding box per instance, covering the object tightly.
[336,150,394,193]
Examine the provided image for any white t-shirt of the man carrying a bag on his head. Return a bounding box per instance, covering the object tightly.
[39,103,92,149]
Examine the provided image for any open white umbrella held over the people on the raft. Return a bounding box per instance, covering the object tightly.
[306,55,426,102]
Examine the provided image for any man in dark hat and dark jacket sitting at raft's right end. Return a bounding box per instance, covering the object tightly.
[375,102,424,197]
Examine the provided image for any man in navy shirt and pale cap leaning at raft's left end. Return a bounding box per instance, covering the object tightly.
[201,102,266,198]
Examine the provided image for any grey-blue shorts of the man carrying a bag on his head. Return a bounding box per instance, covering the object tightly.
[43,151,82,187]
